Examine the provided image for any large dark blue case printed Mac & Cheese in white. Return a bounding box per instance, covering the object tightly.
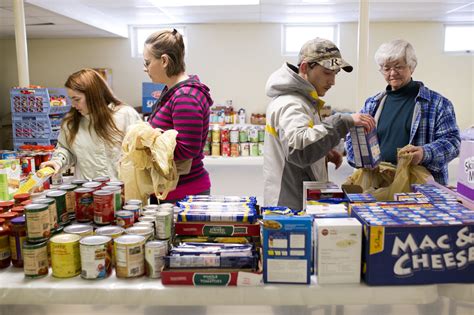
[351,206,474,285]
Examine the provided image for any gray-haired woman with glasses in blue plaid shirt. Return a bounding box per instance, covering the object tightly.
[346,40,460,185]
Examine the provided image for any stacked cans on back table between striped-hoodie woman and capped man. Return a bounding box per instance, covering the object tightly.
[204,125,265,157]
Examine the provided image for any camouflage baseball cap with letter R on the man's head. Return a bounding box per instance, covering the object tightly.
[298,37,353,72]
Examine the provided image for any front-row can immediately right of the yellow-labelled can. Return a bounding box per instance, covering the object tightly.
[79,235,112,280]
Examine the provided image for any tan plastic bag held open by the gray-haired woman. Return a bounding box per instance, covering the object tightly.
[344,148,433,201]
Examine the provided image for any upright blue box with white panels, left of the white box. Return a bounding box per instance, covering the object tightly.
[261,215,313,284]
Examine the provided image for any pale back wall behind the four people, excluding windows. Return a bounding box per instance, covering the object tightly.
[0,23,474,147]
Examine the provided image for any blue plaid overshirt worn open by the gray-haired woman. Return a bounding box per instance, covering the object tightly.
[346,82,461,185]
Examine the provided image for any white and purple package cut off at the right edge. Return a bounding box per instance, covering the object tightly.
[457,127,474,201]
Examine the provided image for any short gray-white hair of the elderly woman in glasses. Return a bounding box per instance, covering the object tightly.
[374,39,418,71]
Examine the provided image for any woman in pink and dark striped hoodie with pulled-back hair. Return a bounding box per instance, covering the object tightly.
[143,30,213,202]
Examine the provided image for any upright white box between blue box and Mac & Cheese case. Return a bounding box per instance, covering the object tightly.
[314,218,362,284]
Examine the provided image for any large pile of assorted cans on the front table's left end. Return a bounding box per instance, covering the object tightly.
[0,177,176,279]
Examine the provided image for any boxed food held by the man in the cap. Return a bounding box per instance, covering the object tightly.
[349,126,381,168]
